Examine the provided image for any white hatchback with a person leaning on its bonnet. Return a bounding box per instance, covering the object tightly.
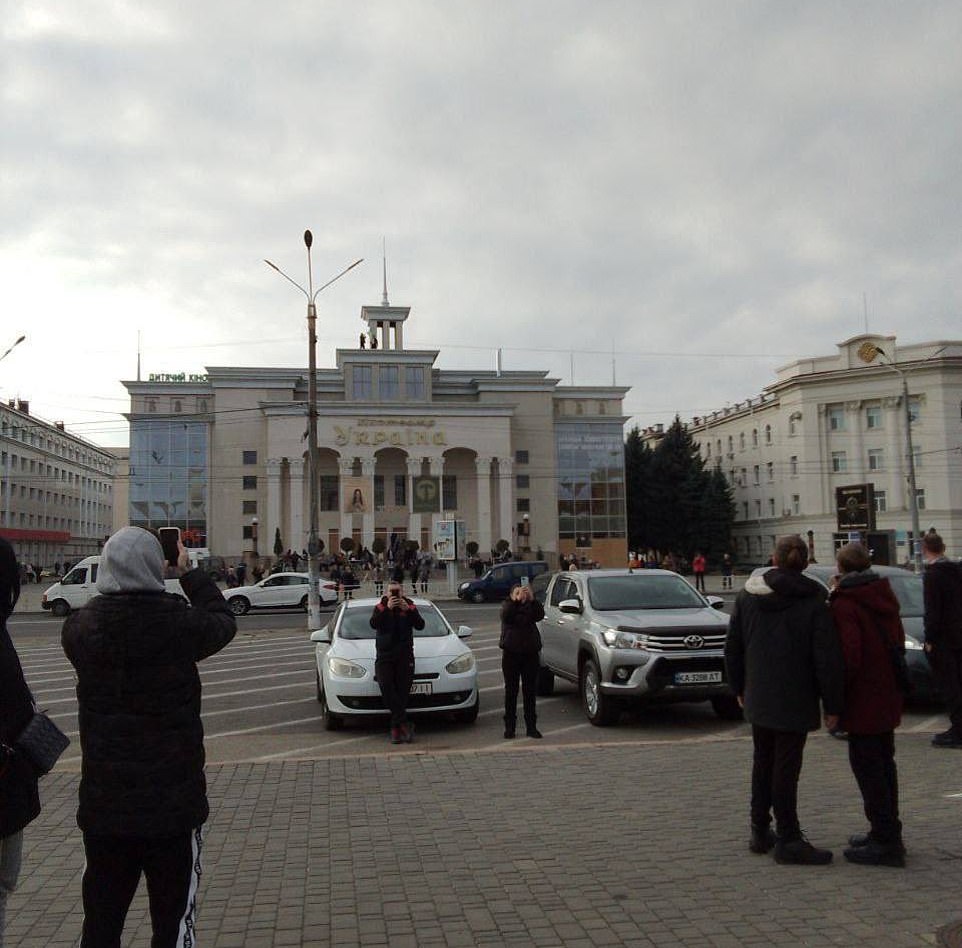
[311,599,479,731]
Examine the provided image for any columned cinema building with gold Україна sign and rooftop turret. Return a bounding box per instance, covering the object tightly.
[124,303,627,565]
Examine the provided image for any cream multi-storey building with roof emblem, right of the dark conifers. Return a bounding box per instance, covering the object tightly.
[646,334,962,564]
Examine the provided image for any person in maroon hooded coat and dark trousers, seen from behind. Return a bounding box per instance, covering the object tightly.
[829,543,905,867]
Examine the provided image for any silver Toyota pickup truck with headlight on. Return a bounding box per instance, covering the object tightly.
[532,569,741,726]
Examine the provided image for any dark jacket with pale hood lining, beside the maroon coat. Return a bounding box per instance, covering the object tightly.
[725,569,844,731]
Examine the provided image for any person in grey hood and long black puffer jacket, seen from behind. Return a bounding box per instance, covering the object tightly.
[61,527,237,948]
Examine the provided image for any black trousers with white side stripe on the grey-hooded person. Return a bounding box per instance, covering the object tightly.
[80,827,201,948]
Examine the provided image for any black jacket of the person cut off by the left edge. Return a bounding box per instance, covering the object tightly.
[0,621,40,838]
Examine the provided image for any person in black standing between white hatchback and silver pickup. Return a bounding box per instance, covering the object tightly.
[500,586,544,740]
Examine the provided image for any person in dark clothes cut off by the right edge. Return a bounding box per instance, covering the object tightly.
[922,533,962,748]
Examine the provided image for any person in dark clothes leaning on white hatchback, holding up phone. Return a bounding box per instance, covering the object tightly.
[371,579,424,744]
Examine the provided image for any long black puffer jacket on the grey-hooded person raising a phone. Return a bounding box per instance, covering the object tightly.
[62,570,237,836]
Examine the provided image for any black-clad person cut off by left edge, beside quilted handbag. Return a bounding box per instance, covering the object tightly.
[0,537,40,945]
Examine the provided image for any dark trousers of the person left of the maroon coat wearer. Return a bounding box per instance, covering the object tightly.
[751,724,808,840]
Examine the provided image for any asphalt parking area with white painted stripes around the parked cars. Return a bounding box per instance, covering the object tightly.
[10,603,945,770]
